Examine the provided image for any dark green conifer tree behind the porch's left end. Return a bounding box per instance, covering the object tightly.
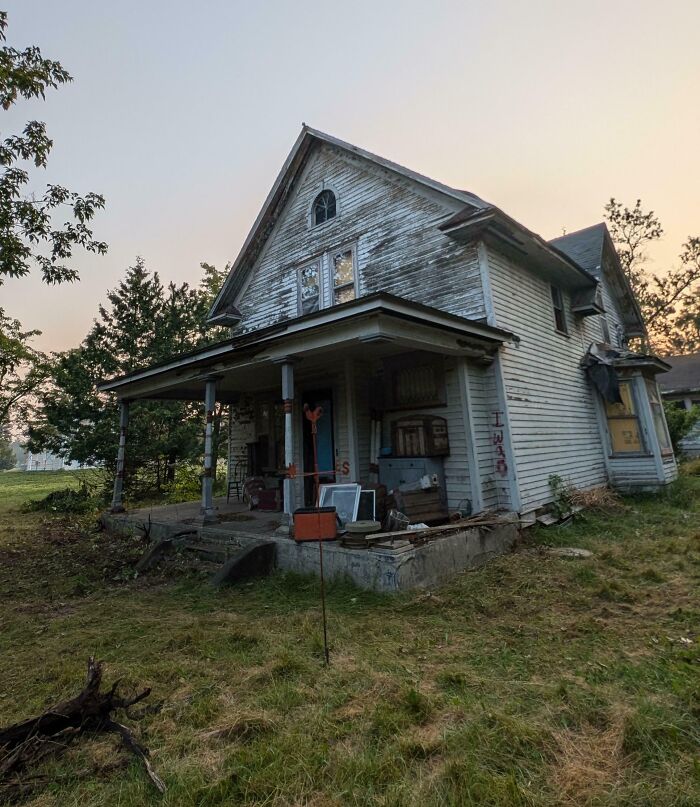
[29,258,227,492]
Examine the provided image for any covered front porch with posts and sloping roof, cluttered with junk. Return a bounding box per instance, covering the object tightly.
[101,294,517,524]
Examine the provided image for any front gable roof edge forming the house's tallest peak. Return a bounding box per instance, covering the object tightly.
[208,124,488,324]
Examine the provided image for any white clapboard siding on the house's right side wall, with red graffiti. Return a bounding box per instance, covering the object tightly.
[487,247,607,511]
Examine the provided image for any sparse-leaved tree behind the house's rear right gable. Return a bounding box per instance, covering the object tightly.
[605,198,700,355]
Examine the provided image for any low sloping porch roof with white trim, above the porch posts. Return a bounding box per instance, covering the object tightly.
[98,292,517,402]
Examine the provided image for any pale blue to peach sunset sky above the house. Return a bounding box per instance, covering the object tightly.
[0,0,700,350]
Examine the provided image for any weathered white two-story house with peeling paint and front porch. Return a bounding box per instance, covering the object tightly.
[101,126,676,517]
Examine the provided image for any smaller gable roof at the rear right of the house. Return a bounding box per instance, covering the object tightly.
[549,221,646,337]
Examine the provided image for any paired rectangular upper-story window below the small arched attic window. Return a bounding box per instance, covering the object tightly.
[298,247,357,316]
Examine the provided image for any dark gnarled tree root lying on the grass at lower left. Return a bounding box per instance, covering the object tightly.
[0,657,165,793]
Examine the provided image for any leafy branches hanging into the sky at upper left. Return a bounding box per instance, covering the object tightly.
[0,11,107,284]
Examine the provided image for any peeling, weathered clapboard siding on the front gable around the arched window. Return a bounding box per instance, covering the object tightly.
[232,144,485,331]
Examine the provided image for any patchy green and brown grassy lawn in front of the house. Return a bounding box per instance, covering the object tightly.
[0,473,700,807]
